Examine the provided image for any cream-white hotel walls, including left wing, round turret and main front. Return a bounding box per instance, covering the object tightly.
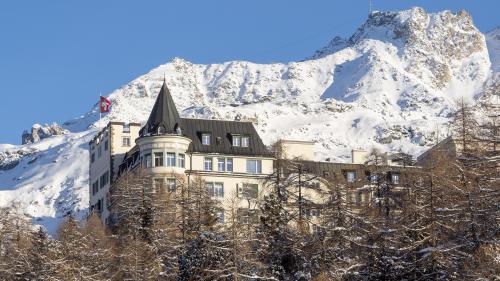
[90,122,274,222]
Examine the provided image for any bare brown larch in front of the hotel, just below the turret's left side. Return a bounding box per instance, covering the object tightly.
[110,169,163,280]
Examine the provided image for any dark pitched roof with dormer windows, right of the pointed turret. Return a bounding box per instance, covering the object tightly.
[181,118,270,156]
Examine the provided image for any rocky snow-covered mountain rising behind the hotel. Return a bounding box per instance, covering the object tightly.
[0,8,500,231]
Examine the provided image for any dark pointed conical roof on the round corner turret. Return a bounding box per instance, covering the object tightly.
[139,80,181,137]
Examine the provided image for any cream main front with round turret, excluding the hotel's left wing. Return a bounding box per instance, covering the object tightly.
[137,135,274,220]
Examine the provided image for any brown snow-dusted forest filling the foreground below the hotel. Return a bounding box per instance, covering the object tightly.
[0,101,500,281]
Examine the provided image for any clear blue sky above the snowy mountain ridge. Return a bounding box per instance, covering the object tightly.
[0,0,500,144]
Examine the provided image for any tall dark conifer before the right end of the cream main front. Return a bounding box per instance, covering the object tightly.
[257,141,312,280]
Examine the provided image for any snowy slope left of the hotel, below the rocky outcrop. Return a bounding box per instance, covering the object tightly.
[0,130,96,233]
